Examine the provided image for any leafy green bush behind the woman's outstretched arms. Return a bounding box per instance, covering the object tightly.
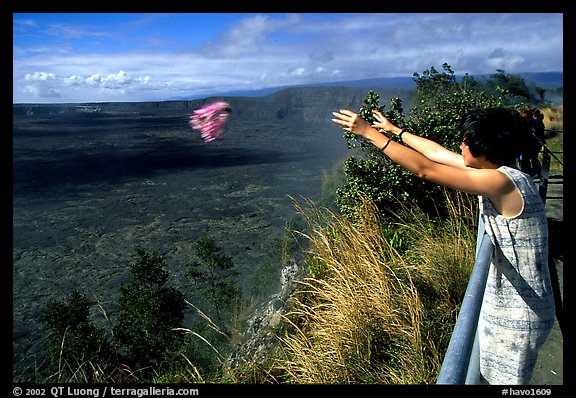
[336,64,502,218]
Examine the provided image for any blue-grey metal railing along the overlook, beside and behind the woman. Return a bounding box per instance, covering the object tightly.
[436,135,562,384]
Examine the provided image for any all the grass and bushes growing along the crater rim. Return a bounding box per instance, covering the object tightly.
[30,64,563,384]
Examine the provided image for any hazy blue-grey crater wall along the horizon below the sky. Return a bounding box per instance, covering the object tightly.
[12,87,411,126]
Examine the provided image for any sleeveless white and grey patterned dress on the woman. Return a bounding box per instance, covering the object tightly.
[478,166,555,384]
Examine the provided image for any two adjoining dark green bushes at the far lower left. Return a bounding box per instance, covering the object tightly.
[41,248,185,382]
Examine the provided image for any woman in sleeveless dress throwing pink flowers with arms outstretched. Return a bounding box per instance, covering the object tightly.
[332,108,555,384]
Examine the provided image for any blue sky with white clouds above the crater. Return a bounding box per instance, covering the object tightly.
[12,12,564,103]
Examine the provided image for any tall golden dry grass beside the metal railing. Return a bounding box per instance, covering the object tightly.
[278,194,476,384]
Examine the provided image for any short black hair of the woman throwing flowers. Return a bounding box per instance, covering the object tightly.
[460,108,527,166]
